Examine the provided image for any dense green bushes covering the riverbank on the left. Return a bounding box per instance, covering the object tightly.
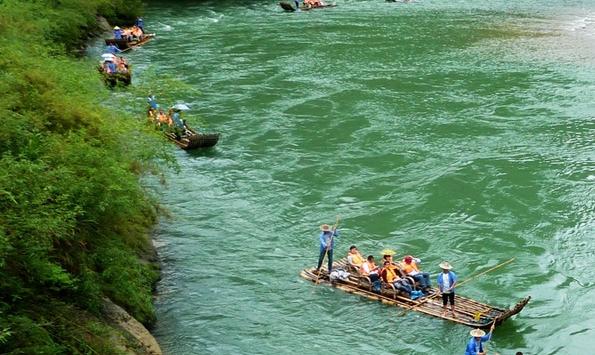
[0,0,172,354]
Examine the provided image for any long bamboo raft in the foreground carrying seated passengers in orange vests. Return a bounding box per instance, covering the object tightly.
[300,258,531,328]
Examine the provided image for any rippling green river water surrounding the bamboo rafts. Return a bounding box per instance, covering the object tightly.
[127,0,595,355]
